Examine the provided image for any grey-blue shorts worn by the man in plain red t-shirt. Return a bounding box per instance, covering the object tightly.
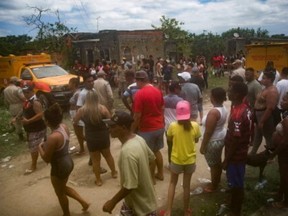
[138,128,164,152]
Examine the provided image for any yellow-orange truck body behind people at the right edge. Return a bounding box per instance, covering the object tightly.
[245,43,288,75]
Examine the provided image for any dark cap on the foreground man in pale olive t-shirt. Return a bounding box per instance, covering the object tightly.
[104,110,134,128]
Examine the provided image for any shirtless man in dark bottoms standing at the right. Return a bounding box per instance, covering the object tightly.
[250,69,279,154]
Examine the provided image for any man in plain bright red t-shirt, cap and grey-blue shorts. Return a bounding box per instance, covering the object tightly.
[132,71,164,183]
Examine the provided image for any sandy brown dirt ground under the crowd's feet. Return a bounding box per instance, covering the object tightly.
[0,101,288,216]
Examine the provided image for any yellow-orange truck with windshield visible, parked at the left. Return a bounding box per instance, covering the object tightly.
[0,53,77,106]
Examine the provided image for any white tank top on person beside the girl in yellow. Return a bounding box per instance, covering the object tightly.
[202,106,228,141]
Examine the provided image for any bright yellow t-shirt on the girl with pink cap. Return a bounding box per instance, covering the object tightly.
[167,121,201,165]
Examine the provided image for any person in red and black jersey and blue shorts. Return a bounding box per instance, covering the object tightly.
[223,83,253,216]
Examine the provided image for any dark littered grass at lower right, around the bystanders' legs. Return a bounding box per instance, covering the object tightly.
[172,162,279,216]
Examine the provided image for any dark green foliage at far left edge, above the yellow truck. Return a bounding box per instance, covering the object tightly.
[0,35,32,56]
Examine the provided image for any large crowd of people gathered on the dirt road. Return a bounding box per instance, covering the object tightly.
[4,55,288,216]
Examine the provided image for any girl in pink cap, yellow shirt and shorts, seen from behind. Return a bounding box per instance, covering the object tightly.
[165,100,201,216]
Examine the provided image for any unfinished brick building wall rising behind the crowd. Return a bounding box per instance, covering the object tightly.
[73,30,164,66]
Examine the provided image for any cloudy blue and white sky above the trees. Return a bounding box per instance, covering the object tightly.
[0,0,288,36]
